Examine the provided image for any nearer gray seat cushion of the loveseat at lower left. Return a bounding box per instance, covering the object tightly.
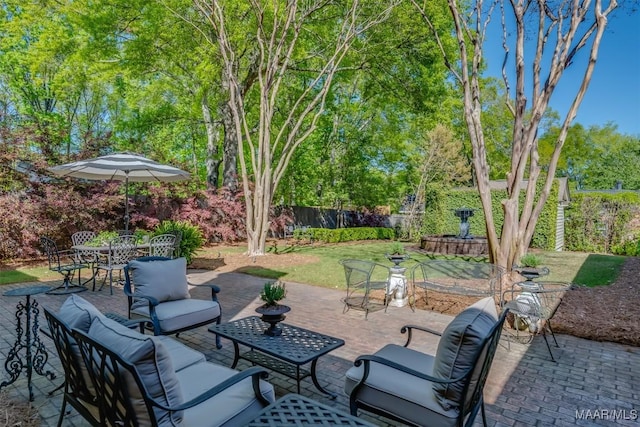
[177,363,275,427]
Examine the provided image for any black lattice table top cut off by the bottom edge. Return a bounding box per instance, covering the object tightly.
[248,393,373,427]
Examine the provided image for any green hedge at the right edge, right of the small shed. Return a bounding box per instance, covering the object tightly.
[565,191,640,255]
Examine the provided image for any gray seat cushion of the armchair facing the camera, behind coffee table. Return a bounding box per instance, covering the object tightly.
[131,299,220,332]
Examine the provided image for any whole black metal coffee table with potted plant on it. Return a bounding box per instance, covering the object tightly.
[209,316,344,399]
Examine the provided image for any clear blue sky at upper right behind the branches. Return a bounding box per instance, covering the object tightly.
[485,9,640,137]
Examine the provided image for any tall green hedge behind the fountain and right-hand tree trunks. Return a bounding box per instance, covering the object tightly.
[422,181,558,250]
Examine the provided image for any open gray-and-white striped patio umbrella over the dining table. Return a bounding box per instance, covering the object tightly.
[49,153,190,230]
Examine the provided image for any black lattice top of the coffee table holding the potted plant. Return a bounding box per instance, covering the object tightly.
[209,316,344,365]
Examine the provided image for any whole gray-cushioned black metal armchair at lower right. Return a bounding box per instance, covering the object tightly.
[345,298,506,426]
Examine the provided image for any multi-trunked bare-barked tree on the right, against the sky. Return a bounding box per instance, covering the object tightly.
[411,0,618,269]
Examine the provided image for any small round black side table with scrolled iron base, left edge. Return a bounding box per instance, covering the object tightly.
[0,286,56,402]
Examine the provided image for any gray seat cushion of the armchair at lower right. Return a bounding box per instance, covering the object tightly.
[344,344,458,426]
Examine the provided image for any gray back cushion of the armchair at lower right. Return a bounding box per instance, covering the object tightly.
[432,297,498,411]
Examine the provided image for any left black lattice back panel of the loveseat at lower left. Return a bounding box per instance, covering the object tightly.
[44,307,101,427]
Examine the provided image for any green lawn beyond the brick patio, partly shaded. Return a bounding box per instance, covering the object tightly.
[0,242,625,288]
